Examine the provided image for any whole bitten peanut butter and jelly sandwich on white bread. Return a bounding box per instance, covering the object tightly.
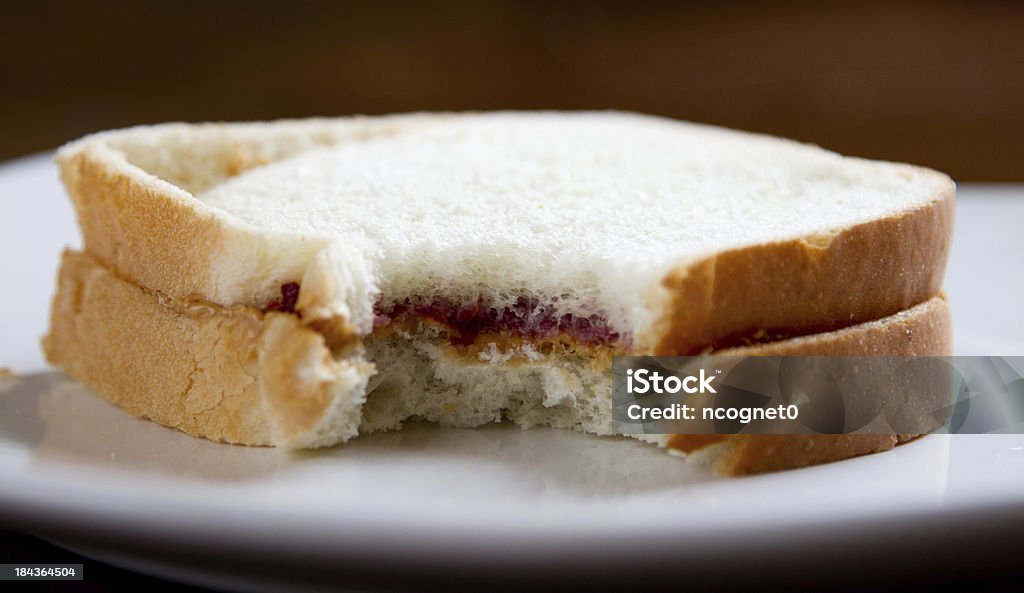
[37,112,954,475]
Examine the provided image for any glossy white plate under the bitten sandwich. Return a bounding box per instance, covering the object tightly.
[0,156,1024,589]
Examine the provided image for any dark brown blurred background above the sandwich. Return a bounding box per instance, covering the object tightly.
[0,0,1024,181]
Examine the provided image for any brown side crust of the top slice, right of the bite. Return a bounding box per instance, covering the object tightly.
[652,190,954,355]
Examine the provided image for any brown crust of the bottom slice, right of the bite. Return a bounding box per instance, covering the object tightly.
[667,295,952,475]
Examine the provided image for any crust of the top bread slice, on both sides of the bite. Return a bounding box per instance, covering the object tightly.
[57,114,955,355]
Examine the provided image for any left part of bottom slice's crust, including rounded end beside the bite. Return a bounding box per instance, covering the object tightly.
[43,252,362,447]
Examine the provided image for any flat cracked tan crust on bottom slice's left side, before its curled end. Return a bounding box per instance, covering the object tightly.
[43,247,270,444]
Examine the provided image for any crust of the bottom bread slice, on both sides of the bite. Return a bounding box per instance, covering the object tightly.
[43,252,951,475]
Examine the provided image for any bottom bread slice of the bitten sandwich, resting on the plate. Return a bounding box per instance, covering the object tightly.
[43,252,951,474]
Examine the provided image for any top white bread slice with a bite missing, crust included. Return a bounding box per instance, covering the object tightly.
[57,113,954,354]
